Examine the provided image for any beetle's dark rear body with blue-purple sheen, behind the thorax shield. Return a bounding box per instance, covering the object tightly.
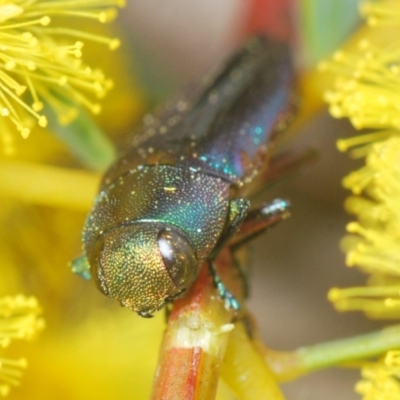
[103,37,294,186]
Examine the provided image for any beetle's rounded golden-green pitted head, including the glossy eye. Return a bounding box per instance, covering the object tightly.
[89,221,199,317]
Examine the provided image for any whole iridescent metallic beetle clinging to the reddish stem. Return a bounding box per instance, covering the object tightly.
[73,37,296,317]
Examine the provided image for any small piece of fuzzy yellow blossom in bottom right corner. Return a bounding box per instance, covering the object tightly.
[356,351,400,400]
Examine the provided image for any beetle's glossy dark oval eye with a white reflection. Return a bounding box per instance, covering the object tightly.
[158,228,198,289]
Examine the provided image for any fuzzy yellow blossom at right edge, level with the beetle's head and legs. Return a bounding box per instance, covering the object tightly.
[329,136,400,319]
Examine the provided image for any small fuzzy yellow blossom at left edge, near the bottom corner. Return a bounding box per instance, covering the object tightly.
[0,295,44,396]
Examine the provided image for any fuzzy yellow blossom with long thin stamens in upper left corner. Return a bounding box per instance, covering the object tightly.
[0,0,123,153]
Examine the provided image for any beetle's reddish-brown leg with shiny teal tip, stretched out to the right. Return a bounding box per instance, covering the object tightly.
[230,199,290,250]
